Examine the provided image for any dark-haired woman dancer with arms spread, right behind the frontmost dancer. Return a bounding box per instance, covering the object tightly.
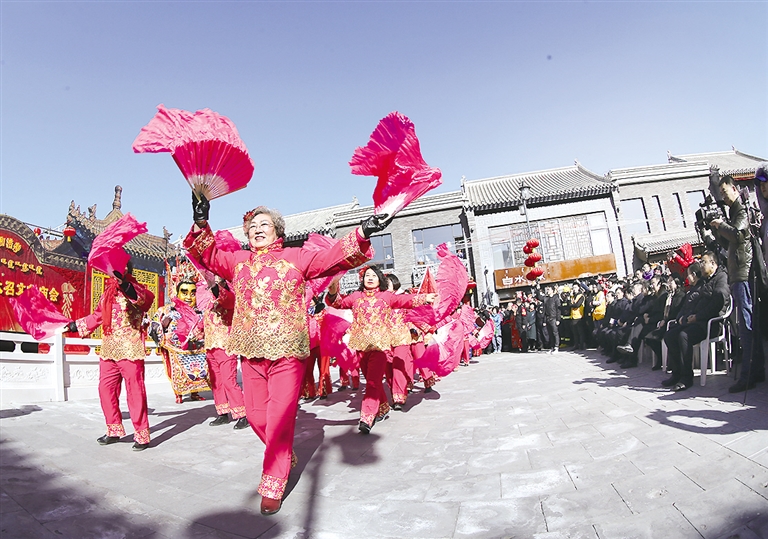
[326,266,435,434]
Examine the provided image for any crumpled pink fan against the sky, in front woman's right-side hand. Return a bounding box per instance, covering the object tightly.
[349,112,442,217]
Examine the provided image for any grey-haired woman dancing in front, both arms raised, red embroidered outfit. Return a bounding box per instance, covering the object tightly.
[184,195,388,515]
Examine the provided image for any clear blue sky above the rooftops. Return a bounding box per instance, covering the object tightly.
[0,0,768,239]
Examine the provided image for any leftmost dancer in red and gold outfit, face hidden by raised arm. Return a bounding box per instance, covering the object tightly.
[68,262,155,451]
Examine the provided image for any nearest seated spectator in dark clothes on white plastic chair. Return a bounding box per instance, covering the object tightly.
[661,251,731,391]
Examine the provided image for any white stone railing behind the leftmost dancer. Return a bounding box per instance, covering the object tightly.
[0,332,171,407]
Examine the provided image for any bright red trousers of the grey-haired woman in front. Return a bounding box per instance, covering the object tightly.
[240,357,304,500]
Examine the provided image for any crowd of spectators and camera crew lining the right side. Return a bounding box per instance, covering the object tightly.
[481,164,768,393]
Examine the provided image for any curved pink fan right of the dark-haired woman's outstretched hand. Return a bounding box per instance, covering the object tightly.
[405,243,469,326]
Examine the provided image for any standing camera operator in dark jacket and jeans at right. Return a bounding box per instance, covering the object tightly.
[710,176,765,393]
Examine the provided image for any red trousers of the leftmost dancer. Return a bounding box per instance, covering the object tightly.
[99,359,149,444]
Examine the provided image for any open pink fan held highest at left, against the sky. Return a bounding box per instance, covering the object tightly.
[133,104,253,200]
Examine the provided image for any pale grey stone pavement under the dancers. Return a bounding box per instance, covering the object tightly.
[0,351,768,539]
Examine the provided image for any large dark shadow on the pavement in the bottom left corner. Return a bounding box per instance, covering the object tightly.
[0,440,157,539]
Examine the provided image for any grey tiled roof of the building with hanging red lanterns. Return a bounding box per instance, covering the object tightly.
[463,163,612,211]
